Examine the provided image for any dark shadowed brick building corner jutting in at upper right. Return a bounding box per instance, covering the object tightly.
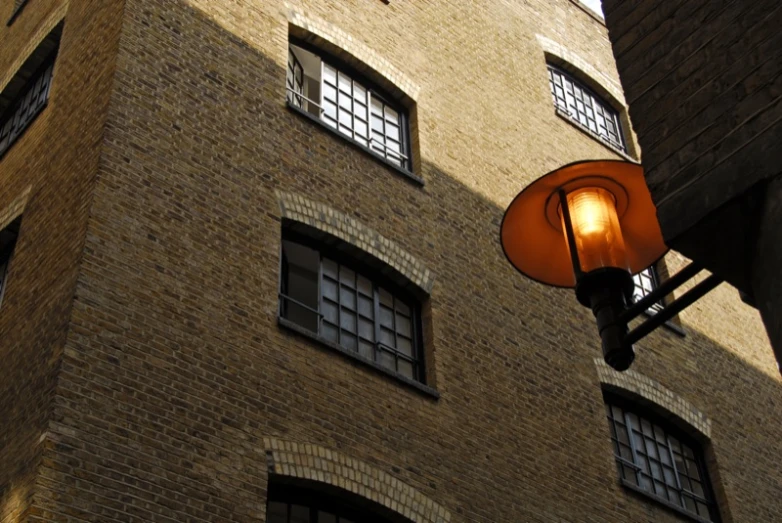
[603,0,782,361]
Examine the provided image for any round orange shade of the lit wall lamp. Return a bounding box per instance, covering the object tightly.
[500,160,668,287]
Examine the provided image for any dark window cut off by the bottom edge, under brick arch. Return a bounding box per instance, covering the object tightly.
[266,481,409,523]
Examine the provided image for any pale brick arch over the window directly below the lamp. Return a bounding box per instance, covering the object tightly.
[595,358,711,438]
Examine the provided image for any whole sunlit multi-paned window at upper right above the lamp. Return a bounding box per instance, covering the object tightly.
[548,64,626,152]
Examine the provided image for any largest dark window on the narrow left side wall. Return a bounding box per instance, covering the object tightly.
[0,24,62,157]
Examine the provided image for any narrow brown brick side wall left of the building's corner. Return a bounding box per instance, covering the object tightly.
[0,0,121,523]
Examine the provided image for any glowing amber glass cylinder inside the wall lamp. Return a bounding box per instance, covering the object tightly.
[562,187,629,272]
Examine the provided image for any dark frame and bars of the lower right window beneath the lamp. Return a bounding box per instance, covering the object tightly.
[603,396,722,523]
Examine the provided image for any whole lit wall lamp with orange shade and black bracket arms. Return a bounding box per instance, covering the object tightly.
[500,160,722,370]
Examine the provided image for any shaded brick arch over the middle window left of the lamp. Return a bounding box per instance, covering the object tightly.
[276,191,434,294]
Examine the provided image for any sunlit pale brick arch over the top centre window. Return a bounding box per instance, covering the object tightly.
[286,4,421,102]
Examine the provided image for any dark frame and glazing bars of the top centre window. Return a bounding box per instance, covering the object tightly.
[285,35,424,185]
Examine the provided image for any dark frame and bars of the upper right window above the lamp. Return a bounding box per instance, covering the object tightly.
[546,60,630,152]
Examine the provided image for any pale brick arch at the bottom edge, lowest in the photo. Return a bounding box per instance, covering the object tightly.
[263,438,451,523]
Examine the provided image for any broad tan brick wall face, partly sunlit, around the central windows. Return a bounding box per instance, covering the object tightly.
[0,0,782,522]
